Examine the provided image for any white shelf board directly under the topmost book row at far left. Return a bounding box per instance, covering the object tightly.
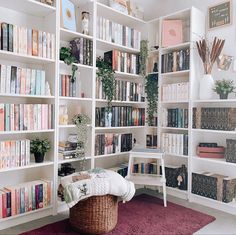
[0,50,55,65]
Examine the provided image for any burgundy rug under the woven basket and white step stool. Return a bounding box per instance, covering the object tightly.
[22,194,215,235]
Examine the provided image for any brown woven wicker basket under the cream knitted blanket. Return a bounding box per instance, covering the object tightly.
[69,195,118,234]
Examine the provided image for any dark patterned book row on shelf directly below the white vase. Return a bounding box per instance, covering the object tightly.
[192,107,236,131]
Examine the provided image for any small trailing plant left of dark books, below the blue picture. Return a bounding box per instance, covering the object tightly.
[60,47,78,82]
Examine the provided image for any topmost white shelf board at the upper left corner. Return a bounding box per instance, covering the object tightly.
[0,0,56,17]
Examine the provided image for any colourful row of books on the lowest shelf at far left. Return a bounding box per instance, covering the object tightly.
[0,180,52,218]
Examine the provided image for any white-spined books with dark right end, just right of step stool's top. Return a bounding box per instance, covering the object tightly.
[161,133,188,155]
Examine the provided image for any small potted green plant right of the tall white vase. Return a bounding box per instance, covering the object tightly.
[213,79,236,99]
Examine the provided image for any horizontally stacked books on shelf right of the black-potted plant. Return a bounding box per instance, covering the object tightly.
[58,141,77,160]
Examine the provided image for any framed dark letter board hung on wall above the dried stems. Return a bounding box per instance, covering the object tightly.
[208,0,233,29]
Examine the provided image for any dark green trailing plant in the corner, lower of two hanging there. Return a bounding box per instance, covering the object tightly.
[145,75,158,126]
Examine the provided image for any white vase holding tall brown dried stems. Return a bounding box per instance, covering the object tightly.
[196,37,225,100]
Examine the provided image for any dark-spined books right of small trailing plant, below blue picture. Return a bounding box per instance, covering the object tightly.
[70,38,93,66]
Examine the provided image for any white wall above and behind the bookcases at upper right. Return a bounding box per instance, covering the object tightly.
[143,0,236,96]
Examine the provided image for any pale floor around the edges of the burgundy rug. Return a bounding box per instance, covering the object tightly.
[0,190,236,235]
